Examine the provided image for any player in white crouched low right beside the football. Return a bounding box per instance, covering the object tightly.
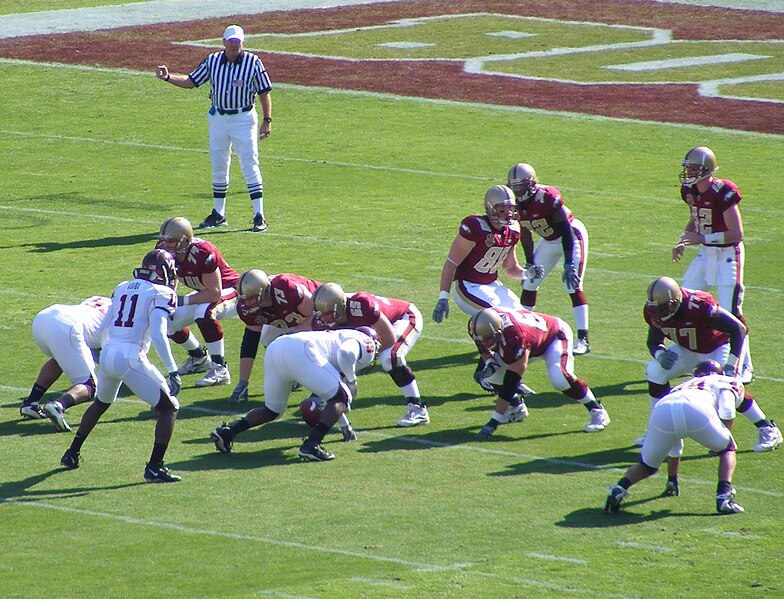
[210,327,380,462]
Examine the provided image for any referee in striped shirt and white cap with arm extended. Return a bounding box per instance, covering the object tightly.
[155,25,272,232]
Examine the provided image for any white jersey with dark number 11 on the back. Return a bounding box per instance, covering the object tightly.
[106,279,177,354]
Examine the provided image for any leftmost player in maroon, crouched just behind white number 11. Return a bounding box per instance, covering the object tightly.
[158,216,240,387]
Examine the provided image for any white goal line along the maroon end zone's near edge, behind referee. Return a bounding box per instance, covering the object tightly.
[0,58,784,140]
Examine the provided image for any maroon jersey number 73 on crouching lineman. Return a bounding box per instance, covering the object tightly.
[237,273,321,329]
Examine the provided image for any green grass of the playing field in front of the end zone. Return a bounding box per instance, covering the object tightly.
[0,24,784,598]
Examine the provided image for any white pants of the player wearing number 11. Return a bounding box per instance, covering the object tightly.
[97,343,180,409]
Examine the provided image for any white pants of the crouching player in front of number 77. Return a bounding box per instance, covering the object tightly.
[640,393,733,468]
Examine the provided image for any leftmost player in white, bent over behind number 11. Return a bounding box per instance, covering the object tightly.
[19,295,112,431]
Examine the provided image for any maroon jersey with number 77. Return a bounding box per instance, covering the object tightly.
[643,289,730,354]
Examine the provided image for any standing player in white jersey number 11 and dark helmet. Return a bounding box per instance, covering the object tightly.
[60,249,181,483]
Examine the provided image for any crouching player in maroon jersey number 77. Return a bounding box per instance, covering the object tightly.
[635,277,782,451]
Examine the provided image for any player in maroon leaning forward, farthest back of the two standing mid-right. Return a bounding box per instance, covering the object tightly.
[507,162,591,356]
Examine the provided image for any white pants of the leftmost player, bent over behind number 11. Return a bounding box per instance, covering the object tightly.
[33,307,95,385]
